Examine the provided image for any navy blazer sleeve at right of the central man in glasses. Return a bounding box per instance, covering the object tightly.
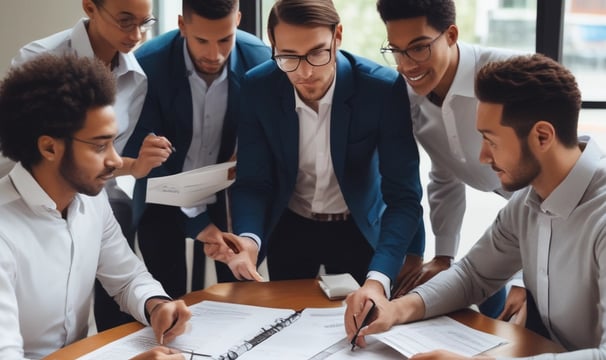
[369,76,424,283]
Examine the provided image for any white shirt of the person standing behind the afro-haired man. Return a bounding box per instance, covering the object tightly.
[10,18,147,156]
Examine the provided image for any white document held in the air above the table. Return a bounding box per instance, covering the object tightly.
[145,161,236,208]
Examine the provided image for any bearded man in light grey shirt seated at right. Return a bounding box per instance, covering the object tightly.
[345,55,606,359]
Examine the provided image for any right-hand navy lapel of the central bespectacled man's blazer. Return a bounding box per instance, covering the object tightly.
[330,52,354,182]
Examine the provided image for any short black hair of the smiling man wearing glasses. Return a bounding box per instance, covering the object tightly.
[377,0,457,32]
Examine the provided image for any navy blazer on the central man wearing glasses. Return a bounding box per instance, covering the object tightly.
[231,51,424,283]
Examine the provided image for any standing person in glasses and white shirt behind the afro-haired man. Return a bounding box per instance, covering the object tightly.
[7,0,176,330]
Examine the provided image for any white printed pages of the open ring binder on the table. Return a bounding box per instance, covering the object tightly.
[79,301,346,360]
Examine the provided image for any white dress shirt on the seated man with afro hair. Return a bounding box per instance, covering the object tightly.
[0,163,167,359]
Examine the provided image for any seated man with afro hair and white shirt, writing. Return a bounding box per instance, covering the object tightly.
[0,54,191,359]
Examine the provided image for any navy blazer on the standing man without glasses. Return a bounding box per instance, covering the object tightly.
[124,30,271,238]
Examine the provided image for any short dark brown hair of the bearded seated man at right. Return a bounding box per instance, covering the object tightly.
[475,54,581,148]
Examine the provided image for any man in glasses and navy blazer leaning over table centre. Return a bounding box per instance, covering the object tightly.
[205,0,424,303]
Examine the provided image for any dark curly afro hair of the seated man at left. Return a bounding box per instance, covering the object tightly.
[0,54,116,168]
